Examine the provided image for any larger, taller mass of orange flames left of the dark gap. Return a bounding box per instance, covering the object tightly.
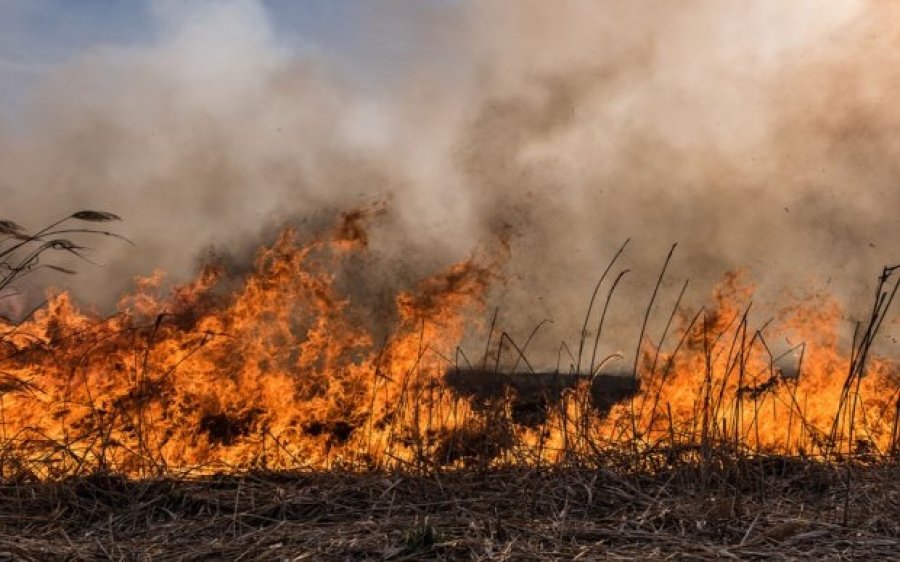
[0,223,490,476]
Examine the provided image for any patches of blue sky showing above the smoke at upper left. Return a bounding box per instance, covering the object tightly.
[0,0,442,120]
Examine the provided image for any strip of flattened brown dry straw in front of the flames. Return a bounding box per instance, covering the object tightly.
[0,457,900,561]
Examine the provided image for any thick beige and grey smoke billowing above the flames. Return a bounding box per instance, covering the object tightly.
[0,0,900,358]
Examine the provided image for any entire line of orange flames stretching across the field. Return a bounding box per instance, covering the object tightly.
[0,219,898,478]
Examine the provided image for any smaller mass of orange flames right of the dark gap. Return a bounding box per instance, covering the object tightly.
[536,273,900,457]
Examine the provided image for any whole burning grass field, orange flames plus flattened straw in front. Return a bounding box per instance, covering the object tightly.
[0,210,900,559]
